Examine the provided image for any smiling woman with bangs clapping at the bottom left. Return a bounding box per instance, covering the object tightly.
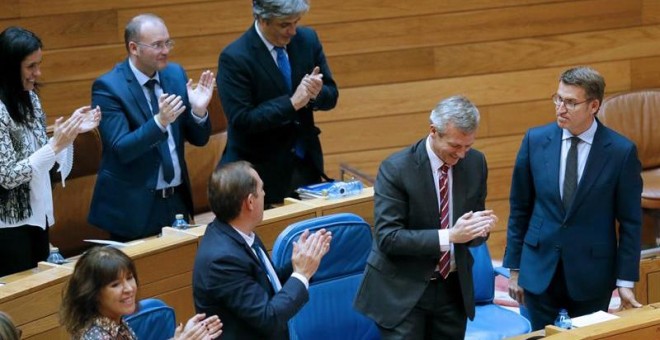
[60,247,222,340]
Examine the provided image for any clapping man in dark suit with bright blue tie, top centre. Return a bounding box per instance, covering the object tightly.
[218,0,338,205]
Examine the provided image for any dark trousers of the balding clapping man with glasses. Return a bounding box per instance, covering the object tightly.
[110,184,192,242]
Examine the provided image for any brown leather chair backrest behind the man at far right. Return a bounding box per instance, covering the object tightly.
[597,89,660,169]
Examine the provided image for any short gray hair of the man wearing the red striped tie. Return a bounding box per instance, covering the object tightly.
[430,96,479,134]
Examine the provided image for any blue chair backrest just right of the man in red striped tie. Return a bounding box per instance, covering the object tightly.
[470,242,495,304]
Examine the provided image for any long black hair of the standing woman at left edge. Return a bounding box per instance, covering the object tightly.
[0,26,43,124]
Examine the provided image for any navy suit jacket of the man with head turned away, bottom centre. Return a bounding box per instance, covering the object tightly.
[193,219,309,340]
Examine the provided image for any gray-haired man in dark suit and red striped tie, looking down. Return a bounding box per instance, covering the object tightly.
[355,96,497,339]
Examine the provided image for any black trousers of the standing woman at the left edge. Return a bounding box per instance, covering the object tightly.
[0,225,50,276]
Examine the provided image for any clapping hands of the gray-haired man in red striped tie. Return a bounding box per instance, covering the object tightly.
[449,210,498,243]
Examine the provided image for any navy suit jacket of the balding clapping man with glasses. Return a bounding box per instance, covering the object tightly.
[88,60,211,238]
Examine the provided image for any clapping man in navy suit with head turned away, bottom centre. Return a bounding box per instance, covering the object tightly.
[193,161,332,340]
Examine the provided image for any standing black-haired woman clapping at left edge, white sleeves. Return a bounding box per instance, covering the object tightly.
[0,27,101,276]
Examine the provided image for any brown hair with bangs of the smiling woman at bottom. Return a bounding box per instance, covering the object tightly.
[60,247,138,337]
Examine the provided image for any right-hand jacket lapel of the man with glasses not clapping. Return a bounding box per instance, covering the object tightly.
[569,120,612,212]
